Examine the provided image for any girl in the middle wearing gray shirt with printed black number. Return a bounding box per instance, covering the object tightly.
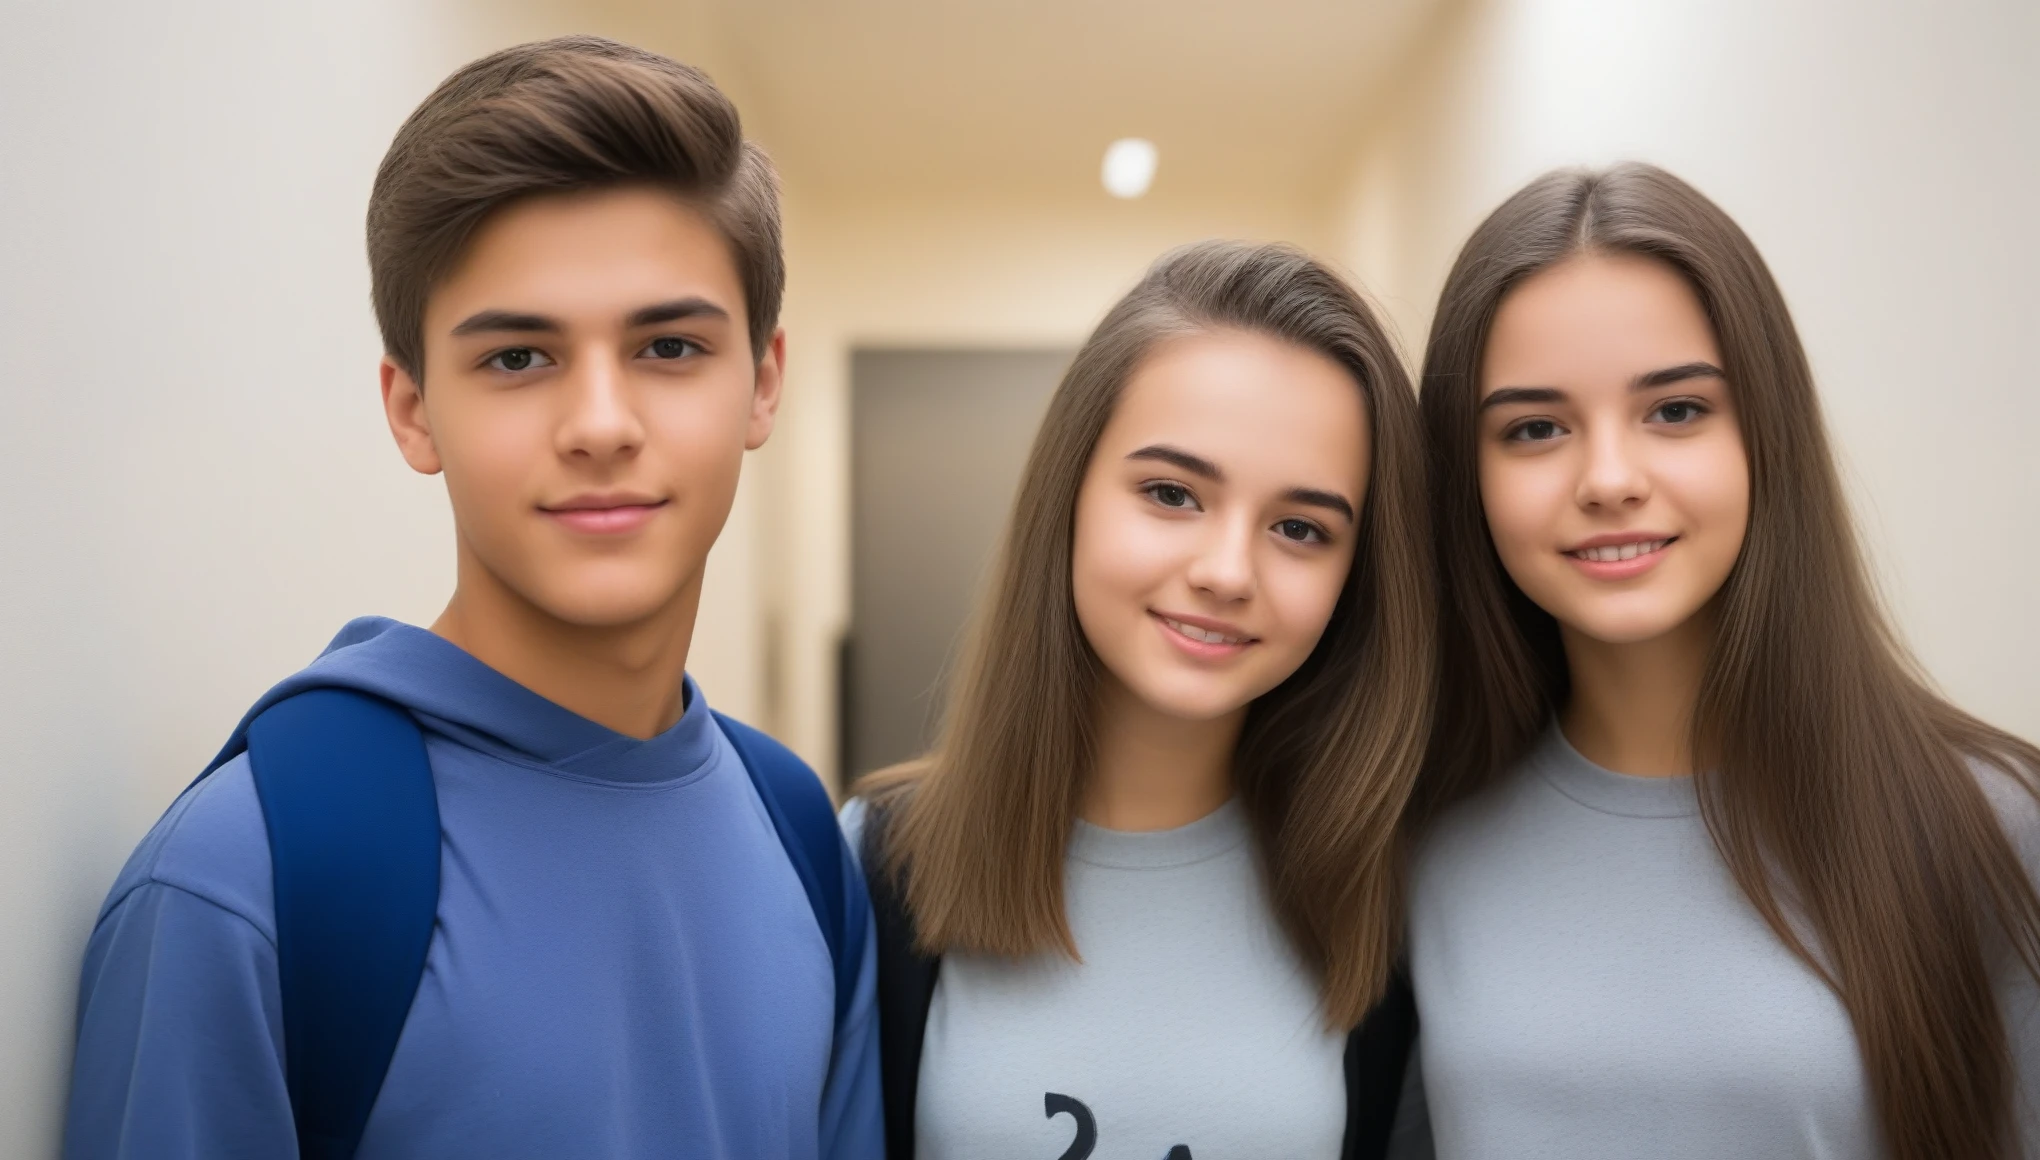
[845,243,1436,1160]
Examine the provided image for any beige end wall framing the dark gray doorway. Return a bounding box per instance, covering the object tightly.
[757,187,1322,777]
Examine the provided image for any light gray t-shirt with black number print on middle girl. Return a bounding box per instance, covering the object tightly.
[843,801,1346,1160]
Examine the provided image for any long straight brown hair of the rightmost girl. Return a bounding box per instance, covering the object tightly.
[1416,165,2040,1160]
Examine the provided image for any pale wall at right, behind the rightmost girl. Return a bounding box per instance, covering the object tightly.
[1332,0,2040,736]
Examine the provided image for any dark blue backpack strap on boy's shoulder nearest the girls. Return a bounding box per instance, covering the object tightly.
[716,714,871,1027]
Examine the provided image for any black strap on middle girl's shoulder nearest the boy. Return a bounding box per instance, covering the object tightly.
[857,801,942,1160]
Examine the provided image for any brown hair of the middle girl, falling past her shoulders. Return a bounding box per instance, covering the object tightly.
[859,243,1436,1027]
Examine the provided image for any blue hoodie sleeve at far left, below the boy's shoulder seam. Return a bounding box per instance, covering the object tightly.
[63,881,298,1160]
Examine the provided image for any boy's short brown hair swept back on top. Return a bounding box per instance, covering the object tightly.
[369,37,785,381]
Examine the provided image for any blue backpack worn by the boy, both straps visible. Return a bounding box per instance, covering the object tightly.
[200,687,871,1160]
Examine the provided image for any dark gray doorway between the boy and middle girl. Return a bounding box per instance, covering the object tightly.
[840,349,1071,779]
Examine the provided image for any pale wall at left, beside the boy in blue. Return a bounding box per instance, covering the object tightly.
[0,2,461,1156]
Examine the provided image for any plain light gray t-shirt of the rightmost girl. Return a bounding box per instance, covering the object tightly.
[1410,728,2040,1160]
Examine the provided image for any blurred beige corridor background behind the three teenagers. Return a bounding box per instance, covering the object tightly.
[0,0,2040,1158]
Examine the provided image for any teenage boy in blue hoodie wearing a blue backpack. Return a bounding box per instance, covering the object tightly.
[65,37,881,1160]
